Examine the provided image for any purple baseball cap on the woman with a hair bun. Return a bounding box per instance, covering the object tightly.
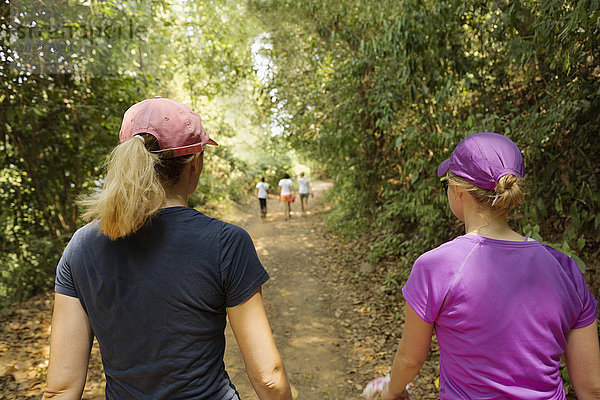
[437,132,525,190]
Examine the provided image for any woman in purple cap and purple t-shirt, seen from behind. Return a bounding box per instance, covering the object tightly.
[368,132,600,400]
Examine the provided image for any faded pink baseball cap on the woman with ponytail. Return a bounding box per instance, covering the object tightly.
[119,96,218,158]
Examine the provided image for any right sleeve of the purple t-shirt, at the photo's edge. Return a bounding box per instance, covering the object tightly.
[544,244,598,329]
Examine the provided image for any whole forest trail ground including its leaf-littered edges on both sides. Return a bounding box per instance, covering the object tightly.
[0,182,398,400]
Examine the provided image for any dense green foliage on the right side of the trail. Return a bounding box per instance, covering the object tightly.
[251,0,600,295]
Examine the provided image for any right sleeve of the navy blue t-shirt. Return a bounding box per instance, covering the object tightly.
[220,224,269,307]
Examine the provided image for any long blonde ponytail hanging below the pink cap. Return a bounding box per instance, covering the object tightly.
[78,137,166,240]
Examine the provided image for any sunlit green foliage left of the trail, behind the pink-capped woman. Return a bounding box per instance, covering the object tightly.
[0,0,268,308]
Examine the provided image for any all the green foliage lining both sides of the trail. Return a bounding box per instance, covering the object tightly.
[0,0,600,312]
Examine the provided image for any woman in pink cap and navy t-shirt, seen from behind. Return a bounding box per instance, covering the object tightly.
[43,98,292,400]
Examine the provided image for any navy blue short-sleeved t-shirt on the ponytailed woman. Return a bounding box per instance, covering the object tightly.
[55,207,269,400]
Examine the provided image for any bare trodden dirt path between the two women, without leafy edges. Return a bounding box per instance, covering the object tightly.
[225,183,360,400]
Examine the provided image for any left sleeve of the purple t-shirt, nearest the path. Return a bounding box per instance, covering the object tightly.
[402,244,456,324]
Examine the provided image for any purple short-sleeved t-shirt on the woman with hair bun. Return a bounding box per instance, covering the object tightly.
[402,235,598,399]
